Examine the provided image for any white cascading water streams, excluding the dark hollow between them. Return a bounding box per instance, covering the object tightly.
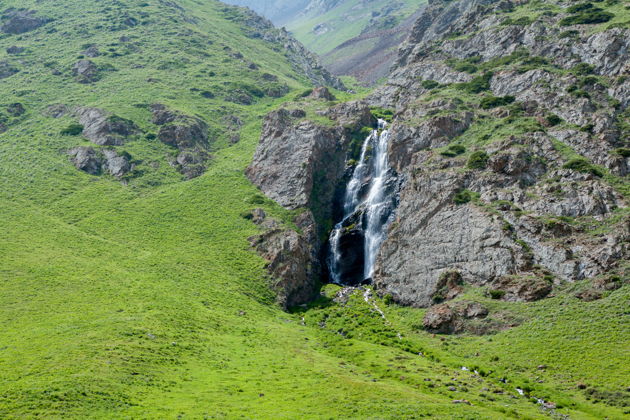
[328,120,393,284]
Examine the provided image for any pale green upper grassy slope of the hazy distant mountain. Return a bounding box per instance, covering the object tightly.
[287,0,425,55]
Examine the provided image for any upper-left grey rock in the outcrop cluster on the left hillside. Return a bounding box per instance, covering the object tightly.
[76,107,139,146]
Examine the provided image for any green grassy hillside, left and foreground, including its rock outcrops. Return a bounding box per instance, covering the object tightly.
[0,0,628,419]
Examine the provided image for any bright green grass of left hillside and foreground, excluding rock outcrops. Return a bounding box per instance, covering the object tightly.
[0,0,627,419]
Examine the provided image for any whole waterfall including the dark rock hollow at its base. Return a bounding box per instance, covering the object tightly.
[327,120,396,284]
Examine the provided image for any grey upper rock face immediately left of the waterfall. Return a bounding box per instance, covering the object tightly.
[246,103,373,209]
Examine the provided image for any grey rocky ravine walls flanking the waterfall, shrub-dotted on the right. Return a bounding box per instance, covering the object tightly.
[248,0,630,316]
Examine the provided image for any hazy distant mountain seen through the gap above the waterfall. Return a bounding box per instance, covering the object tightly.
[227,0,426,85]
